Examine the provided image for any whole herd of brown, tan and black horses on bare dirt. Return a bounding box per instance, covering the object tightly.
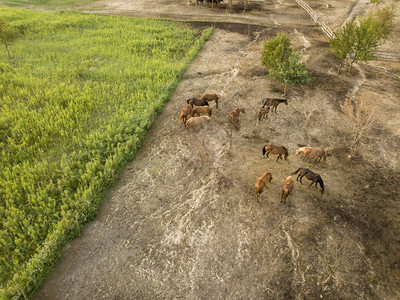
[178,93,326,203]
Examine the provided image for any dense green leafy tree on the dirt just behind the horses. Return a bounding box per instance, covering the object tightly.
[261,33,311,95]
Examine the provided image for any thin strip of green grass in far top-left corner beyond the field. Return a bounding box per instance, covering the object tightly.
[0,0,99,9]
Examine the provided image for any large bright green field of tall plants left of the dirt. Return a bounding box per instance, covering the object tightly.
[0,8,211,299]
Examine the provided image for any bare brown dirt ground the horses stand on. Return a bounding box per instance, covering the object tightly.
[34,0,400,299]
